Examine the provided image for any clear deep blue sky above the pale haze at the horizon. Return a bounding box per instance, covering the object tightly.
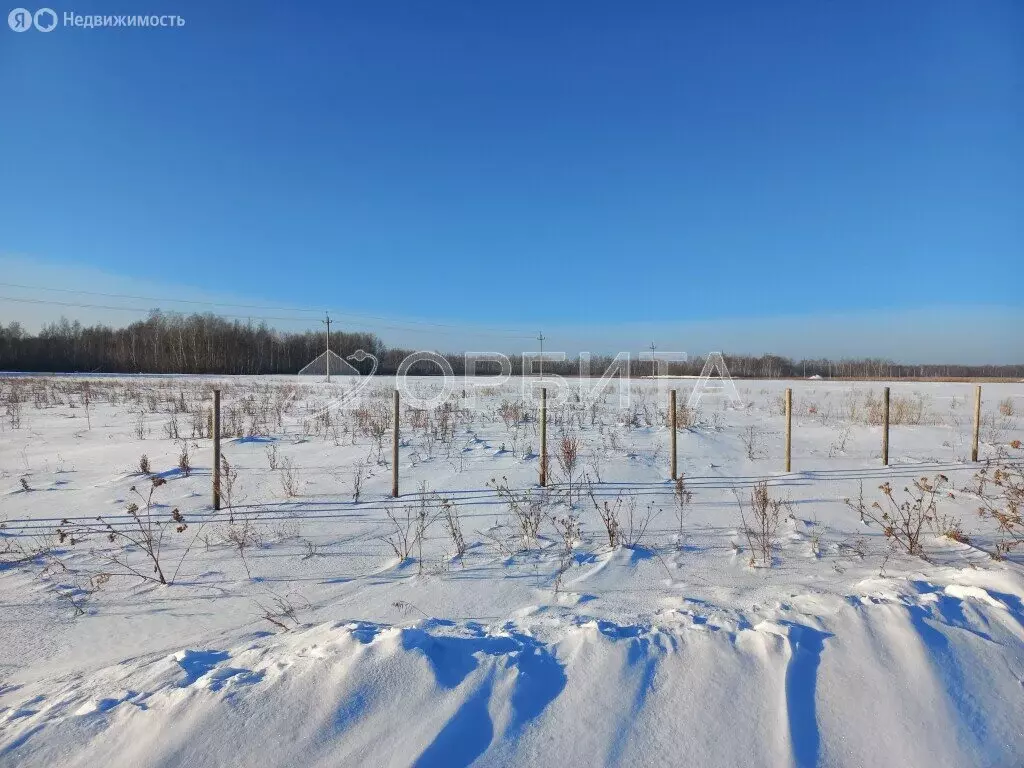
[0,0,1024,358]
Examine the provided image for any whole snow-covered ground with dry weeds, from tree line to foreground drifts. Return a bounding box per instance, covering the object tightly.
[0,377,1024,766]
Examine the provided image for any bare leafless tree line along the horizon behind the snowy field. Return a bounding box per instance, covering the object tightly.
[0,311,1024,379]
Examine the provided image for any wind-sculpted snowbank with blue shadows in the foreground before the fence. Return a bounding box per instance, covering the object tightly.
[0,580,1024,766]
